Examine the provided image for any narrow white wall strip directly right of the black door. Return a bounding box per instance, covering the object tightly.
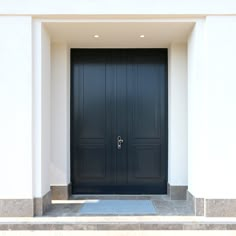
[168,43,188,186]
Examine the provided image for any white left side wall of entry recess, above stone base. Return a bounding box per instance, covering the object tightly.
[33,21,51,197]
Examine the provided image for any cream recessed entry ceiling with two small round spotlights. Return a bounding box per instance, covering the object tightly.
[44,22,194,48]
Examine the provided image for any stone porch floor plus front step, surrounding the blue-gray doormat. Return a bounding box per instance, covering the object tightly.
[0,196,236,230]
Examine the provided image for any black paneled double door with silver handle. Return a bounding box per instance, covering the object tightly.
[71,49,167,194]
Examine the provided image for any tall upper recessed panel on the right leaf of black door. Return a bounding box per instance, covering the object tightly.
[130,61,160,138]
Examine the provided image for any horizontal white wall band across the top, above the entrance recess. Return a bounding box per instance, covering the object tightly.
[0,0,236,16]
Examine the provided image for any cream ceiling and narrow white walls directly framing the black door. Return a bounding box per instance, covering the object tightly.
[48,19,191,202]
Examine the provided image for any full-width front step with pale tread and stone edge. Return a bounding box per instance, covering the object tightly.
[0,216,236,231]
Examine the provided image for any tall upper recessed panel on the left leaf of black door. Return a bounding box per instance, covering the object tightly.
[80,64,106,138]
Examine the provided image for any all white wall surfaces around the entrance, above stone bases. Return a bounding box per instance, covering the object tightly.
[0,0,236,205]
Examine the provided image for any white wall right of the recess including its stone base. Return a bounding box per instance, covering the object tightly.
[188,16,236,216]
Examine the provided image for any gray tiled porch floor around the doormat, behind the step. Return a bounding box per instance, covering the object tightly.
[44,195,194,217]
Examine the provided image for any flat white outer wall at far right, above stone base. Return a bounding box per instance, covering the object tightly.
[205,16,236,199]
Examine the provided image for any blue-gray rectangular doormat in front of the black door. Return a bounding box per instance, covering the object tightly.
[80,200,156,215]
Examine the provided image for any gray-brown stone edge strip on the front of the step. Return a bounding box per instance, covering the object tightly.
[0,222,236,231]
